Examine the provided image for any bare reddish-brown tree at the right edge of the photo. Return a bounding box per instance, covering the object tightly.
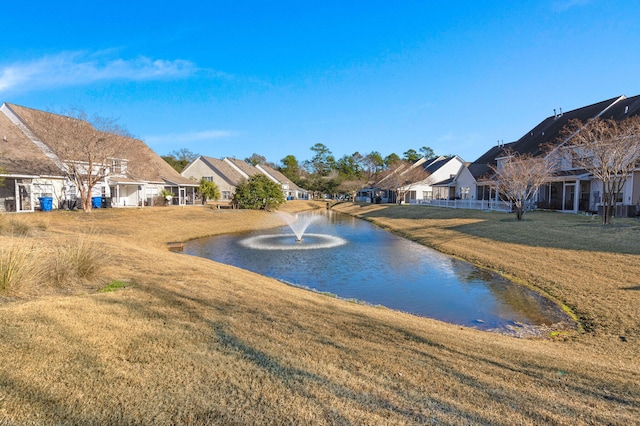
[563,116,640,225]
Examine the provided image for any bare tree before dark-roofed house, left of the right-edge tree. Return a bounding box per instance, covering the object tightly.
[492,150,556,220]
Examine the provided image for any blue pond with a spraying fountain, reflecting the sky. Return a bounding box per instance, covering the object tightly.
[184,211,575,336]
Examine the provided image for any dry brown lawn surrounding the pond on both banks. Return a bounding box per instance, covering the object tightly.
[0,203,640,425]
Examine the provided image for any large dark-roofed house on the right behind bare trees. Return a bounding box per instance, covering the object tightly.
[433,95,640,215]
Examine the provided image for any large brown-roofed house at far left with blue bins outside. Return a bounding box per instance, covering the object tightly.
[0,103,198,212]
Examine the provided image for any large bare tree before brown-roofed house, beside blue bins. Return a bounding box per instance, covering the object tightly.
[38,110,129,212]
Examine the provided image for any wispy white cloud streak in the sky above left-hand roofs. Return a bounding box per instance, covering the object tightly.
[0,52,197,92]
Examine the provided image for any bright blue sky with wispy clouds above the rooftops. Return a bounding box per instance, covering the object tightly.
[0,0,640,163]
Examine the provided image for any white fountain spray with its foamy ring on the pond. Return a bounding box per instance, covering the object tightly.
[240,212,347,250]
